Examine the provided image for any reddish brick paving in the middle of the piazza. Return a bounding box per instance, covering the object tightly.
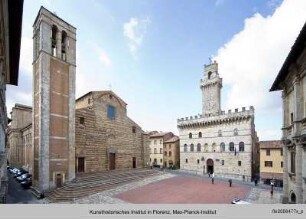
[115,175,251,204]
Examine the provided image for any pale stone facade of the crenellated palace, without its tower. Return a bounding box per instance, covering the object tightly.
[178,108,255,181]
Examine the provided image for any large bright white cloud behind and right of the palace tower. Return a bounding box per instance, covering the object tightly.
[215,0,306,114]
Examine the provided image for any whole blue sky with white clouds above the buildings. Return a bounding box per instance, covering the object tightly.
[7,0,306,140]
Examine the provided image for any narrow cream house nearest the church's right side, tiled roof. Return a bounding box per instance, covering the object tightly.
[150,132,174,167]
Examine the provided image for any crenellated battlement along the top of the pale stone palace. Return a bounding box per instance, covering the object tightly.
[177,106,255,126]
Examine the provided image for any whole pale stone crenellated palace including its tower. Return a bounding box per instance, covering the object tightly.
[177,61,259,181]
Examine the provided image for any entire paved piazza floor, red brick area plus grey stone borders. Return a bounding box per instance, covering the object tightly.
[66,173,281,204]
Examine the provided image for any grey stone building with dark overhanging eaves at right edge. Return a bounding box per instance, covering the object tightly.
[270,23,306,204]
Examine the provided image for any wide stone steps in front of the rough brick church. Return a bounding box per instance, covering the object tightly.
[45,169,161,202]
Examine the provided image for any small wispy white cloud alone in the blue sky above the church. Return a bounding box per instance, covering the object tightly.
[123,17,151,59]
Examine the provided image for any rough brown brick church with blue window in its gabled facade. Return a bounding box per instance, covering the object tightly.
[75,91,149,173]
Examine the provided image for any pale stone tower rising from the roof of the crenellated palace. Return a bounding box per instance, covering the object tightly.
[200,61,222,116]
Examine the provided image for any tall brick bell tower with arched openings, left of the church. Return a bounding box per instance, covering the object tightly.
[32,7,76,192]
